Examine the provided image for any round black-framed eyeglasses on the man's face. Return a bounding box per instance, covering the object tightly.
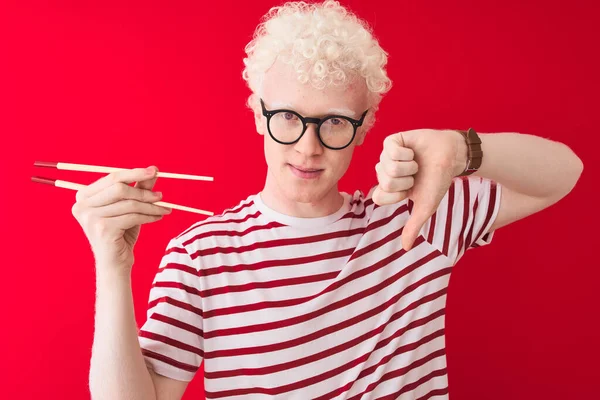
[260,99,369,150]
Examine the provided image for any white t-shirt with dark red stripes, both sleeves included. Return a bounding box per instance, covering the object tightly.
[139,175,501,399]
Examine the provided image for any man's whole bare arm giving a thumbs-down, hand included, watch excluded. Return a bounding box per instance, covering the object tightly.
[372,129,583,251]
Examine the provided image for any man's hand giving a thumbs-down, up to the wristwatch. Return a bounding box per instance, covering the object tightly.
[373,129,467,251]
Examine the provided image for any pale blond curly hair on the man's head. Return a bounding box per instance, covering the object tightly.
[242,0,392,130]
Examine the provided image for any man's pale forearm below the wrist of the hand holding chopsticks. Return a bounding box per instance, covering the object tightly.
[89,268,156,400]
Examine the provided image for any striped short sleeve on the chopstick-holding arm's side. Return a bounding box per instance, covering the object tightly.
[138,239,204,381]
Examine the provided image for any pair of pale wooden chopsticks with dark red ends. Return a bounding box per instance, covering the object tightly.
[31,161,214,216]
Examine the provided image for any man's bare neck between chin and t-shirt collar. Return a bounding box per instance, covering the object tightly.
[260,172,344,218]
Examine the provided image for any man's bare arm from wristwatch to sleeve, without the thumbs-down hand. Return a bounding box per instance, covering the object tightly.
[454,133,583,231]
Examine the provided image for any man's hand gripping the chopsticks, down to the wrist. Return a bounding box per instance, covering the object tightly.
[71,166,171,269]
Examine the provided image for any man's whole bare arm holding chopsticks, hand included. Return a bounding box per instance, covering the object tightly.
[71,166,193,400]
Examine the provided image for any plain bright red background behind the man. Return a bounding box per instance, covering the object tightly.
[0,0,600,400]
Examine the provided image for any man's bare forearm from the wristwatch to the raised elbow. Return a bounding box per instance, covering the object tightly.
[459,133,583,198]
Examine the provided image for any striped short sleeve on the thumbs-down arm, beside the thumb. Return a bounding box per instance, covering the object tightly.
[421,175,502,263]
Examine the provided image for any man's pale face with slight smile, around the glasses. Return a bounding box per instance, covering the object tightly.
[255,61,368,204]
